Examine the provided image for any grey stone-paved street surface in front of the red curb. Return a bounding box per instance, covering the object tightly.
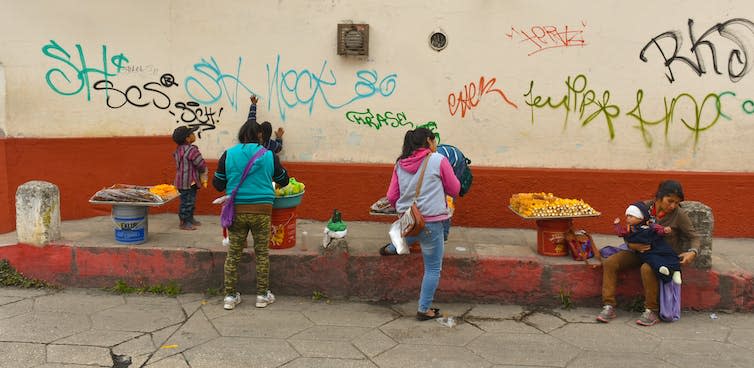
[0,288,754,368]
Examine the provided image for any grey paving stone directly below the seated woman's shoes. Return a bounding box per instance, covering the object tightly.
[550,319,660,353]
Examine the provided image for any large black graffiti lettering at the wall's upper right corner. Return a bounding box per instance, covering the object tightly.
[639,18,754,83]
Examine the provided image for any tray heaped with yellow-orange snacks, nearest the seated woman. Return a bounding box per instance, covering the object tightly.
[510,192,600,218]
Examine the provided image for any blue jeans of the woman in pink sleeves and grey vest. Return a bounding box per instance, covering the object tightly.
[387,221,450,313]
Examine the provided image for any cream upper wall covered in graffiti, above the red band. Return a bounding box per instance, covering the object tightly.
[0,0,754,172]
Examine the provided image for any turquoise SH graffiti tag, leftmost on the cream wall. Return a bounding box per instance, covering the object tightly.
[42,40,128,101]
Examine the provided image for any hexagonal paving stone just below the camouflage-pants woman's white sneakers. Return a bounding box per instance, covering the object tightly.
[212,308,313,339]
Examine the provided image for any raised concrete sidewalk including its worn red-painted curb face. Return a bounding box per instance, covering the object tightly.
[0,214,754,311]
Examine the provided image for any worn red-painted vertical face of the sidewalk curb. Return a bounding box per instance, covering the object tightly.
[0,244,754,311]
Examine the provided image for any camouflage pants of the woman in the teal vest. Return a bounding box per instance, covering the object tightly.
[225,213,271,295]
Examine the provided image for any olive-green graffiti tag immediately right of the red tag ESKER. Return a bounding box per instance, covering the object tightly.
[524,74,620,140]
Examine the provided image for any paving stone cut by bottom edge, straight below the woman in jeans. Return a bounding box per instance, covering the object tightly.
[372,344,490,368]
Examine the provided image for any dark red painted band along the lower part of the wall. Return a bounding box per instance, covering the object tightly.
[0,136,754,237]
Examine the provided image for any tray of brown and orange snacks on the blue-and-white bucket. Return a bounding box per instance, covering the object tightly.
[89,184,178,204]
